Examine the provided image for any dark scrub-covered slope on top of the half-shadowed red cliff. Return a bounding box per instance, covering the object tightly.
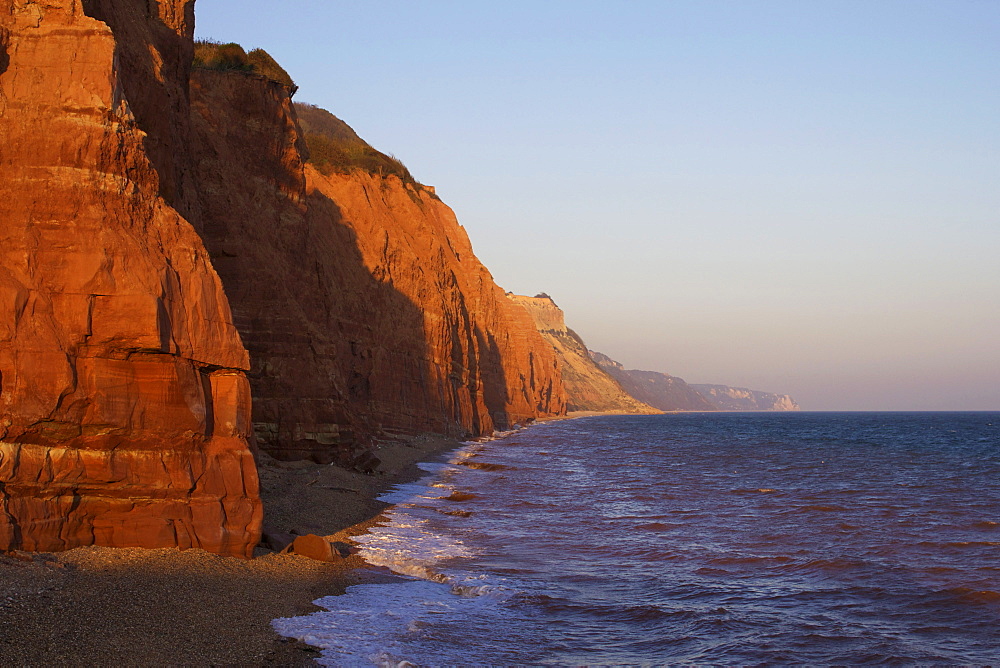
[295,102,421,188]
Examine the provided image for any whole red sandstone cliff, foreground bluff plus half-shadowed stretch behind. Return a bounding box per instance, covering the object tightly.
[0,0,565,556]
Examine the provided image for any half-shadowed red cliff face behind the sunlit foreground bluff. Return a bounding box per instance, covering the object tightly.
[191,75,565,464]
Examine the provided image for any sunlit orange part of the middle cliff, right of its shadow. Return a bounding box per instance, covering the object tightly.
[306,166,565,435]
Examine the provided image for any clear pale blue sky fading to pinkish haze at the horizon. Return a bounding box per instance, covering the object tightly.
[196,0,1000,410]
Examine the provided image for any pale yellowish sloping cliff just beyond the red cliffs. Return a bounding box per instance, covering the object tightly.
[507,294,659,413]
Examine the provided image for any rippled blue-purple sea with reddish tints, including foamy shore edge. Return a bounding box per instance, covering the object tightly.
[274,412,1000,666]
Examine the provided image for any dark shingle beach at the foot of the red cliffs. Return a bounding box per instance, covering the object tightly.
[0,437,460,666]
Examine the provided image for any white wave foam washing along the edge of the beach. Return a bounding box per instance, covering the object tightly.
[273,442,511,668]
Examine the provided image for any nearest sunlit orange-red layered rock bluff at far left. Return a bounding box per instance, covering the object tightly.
[0,0,261,556]
